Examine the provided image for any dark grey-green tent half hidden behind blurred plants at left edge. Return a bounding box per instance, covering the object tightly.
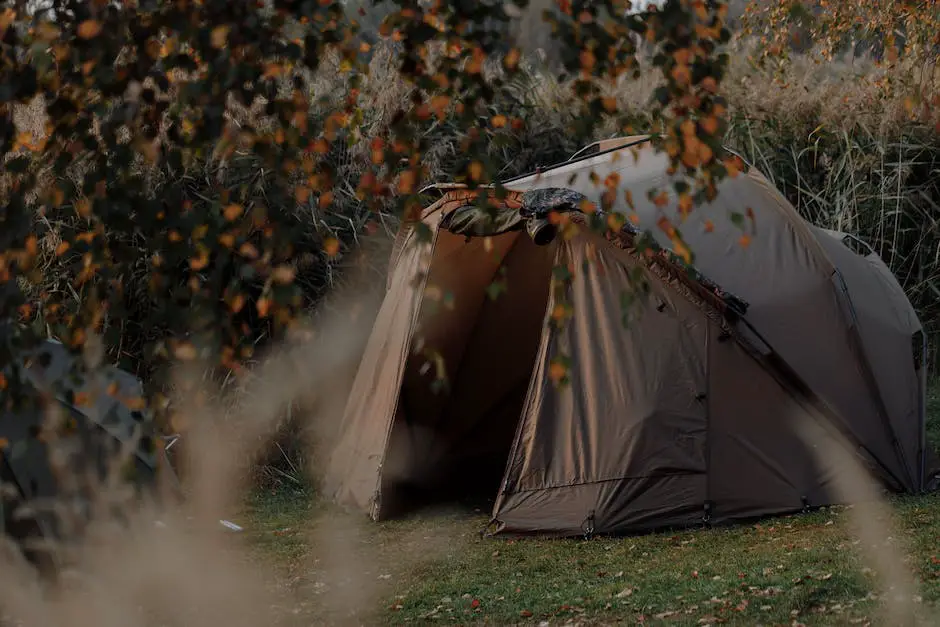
[0,340,176,572]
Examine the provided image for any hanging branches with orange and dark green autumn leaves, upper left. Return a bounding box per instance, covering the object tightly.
[0,0,729,432]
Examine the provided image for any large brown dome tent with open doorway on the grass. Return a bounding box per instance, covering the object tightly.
[325,137,940,535]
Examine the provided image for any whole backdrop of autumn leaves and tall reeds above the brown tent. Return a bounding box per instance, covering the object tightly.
[0,0,940,490]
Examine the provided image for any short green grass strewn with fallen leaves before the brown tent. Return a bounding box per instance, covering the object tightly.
[245,390,940,625]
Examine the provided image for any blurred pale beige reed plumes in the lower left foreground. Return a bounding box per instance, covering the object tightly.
[0,232,462,627]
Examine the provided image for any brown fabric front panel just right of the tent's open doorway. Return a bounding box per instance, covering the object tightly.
[495,233,706,533]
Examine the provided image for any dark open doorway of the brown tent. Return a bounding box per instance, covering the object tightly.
[381,230,555,517]
